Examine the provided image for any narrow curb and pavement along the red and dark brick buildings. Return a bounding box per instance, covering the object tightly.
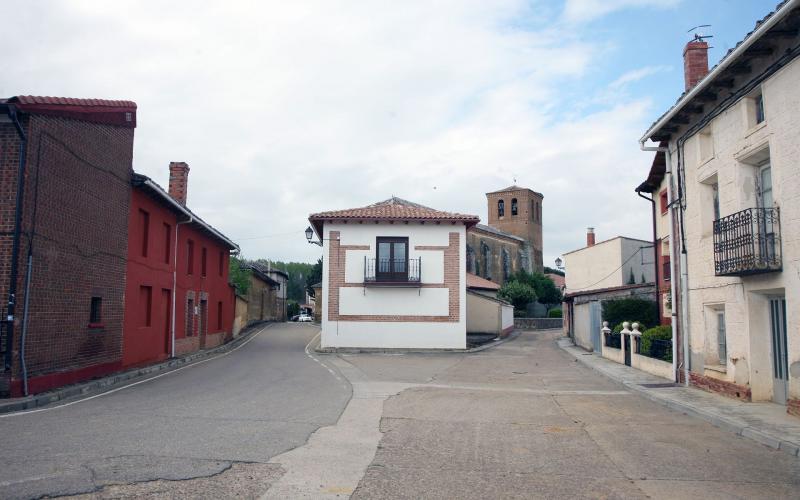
[0,323,272,414]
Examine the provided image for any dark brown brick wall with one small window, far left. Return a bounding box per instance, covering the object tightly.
[0,115,134,394]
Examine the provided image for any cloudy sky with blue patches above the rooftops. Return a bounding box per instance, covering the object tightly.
[0,0,778,266]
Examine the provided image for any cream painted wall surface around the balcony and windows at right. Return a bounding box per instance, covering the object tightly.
[670,53,800,400]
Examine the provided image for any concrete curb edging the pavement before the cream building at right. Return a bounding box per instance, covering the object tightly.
[556,337,800,458]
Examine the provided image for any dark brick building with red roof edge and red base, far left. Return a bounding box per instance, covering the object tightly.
[0,96,136,395]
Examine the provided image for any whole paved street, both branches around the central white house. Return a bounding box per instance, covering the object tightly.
[0,324,800,499]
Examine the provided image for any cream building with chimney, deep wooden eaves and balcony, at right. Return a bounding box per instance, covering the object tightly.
[641,0,800,415]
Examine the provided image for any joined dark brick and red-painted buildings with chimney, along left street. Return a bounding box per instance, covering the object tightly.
[0,96,237,396]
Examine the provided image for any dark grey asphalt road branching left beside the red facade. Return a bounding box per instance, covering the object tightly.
[0,324,351,498]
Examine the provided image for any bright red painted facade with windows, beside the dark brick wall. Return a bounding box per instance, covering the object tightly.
[123,187,234,367]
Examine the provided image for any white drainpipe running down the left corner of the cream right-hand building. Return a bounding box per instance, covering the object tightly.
[639,141,689,386]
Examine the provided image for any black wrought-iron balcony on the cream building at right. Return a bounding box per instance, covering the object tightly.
[714,208,782,276]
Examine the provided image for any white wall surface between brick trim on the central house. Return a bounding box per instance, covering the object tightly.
[322,222,467,349]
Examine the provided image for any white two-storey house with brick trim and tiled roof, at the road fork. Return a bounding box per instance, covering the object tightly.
[309,197,479,349]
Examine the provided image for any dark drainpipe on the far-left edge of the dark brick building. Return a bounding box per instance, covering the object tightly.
[4,104,28,378]
